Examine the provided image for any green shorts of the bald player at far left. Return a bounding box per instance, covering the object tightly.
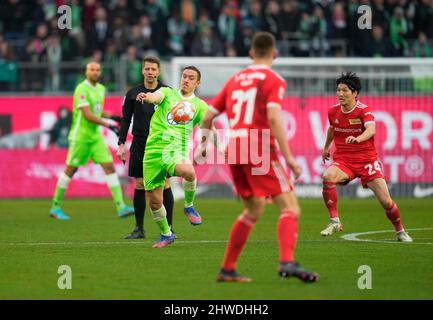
[66,134,113,167]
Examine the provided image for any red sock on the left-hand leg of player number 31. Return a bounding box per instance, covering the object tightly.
[223,213,256,271]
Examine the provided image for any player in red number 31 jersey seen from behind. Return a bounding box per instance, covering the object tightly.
[202,32,319,282]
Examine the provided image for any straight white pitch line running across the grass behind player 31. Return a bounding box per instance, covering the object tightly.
[0,239,342,247]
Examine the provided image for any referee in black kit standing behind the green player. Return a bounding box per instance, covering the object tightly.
[117,57,174,239]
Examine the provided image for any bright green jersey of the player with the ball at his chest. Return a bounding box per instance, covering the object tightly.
[146,87,208,156]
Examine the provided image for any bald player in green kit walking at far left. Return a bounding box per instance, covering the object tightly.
[50,62,134,220]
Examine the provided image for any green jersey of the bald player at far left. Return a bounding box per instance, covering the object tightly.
[69,80,105,141]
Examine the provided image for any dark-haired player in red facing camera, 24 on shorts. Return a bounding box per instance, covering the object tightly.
[321,72,412,242]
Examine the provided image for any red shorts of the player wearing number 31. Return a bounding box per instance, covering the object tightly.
[230,161,293,198]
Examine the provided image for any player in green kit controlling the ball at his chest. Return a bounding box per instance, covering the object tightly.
[137,66,208,248]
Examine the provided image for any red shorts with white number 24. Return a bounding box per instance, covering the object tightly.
[331,159,385,188]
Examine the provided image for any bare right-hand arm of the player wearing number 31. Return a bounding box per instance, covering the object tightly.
[267,108,302,179]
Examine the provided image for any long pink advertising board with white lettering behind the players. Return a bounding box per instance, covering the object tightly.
[0,96,433,198]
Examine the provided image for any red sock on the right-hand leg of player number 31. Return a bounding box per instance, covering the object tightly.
[277,211,298,262]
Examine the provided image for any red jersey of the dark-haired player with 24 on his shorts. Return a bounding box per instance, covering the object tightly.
[328,101,377,163]
